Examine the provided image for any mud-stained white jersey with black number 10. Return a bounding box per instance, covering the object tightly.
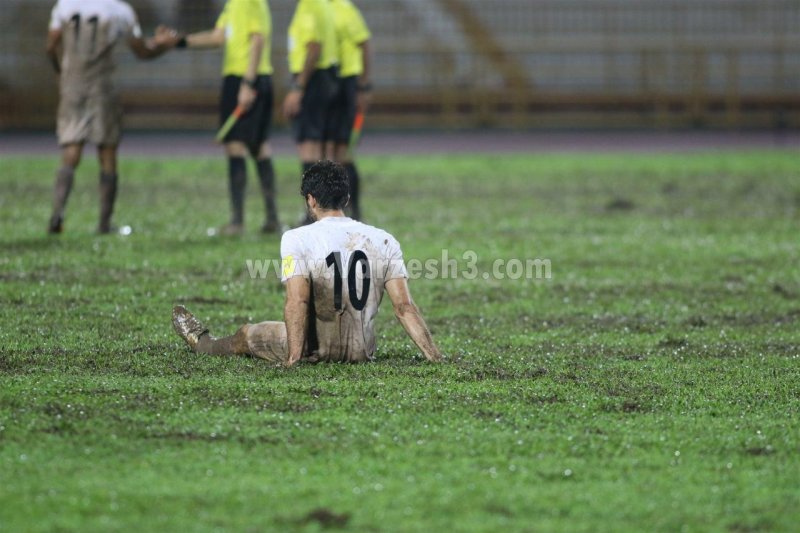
[281,217,408,362]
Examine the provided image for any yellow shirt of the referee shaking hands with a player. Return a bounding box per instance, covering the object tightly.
[216,0,272,76]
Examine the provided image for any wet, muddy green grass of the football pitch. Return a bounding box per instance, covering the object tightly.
[0,151,800,531]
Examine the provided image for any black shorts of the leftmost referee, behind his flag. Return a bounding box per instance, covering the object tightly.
[219,75,272,154]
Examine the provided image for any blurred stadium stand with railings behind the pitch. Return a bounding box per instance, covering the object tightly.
[0,0,800,130]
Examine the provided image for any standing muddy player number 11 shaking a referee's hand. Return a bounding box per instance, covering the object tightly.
[47,0,175,233]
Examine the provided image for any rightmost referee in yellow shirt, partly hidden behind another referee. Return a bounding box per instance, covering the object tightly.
[326,0,372,220]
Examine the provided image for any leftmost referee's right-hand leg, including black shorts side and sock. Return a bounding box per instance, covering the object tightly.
[249,76,280,233]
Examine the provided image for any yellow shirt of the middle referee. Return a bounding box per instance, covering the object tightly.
[289,0,339,74]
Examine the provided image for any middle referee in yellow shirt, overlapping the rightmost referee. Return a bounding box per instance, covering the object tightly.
[283,0,338,220]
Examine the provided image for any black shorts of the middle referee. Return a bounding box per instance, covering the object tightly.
[292,67,338,143]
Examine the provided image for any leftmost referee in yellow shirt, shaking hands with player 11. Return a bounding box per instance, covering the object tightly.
[177,0,280,235]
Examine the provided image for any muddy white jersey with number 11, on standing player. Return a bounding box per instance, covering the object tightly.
[50,0,142,94]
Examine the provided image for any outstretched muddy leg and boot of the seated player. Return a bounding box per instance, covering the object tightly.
[172,306,288,363]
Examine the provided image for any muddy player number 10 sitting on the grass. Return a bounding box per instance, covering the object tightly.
[172,161,441,366]
